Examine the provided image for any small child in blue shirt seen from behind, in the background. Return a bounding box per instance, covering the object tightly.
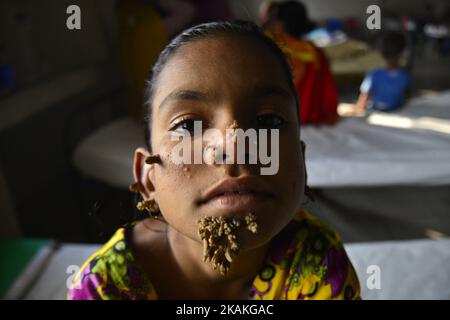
[356,32,411,111]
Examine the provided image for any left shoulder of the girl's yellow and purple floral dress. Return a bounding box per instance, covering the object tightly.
[68,227,156,300]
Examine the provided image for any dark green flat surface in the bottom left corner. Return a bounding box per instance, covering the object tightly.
[0,239,50,297]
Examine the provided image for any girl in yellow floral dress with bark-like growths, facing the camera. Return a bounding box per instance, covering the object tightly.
[69,22,360,300]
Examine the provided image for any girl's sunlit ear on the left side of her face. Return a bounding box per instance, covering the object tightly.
[133,148,155,200]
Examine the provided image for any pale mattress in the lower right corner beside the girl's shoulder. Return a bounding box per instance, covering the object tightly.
[346,239,450,300]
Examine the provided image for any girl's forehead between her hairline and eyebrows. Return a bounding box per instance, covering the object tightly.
[154,36,289,104]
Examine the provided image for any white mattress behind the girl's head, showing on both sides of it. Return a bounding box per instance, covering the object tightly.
[73,91,450,189]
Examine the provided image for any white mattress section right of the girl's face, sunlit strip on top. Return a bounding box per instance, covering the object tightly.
[302,91,450,187]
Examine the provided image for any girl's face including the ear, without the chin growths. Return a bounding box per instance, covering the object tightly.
[135,35,305,250]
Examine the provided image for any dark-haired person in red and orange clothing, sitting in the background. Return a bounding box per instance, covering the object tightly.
[260,1,338,124]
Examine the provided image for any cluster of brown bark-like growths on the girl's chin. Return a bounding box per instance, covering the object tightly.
[198,213,258,275]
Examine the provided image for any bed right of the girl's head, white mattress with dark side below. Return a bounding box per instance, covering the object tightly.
[302,91,450,241]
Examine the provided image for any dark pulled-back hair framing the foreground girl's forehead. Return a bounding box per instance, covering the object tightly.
[144,20,298,152]
